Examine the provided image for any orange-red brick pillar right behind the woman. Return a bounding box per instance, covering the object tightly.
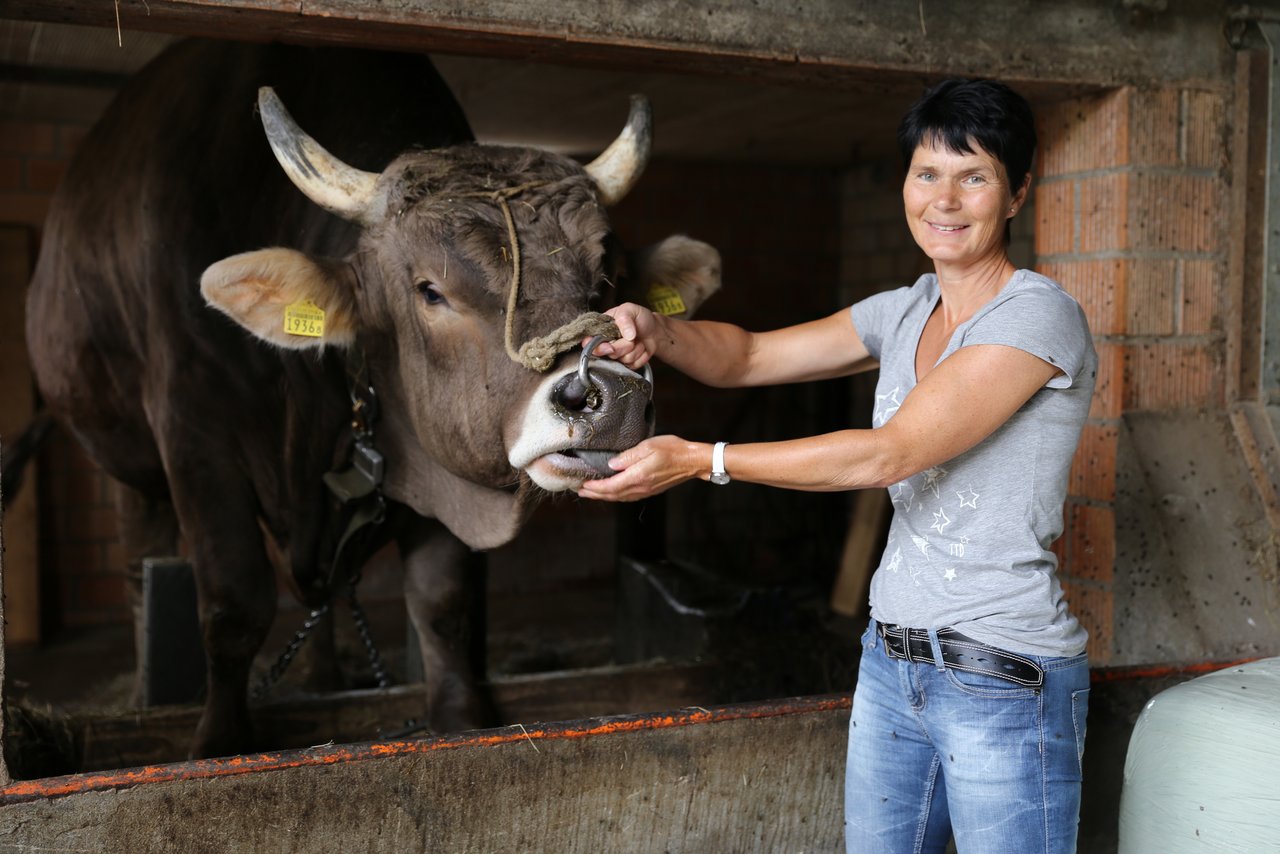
[1036,88,1226,665]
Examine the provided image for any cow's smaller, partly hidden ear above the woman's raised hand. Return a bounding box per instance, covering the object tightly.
[622,234,721,319]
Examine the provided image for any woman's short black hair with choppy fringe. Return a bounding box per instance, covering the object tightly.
[897,77,1036,193]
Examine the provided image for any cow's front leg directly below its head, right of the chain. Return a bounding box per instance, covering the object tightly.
[397,517,494,732]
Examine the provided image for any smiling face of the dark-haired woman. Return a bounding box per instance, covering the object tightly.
[902,138,1027,266]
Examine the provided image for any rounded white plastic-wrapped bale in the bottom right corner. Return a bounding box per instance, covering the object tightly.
[1120,658,1280,854]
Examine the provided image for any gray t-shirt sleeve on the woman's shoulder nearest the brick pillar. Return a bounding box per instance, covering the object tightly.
[961,288,1093,388]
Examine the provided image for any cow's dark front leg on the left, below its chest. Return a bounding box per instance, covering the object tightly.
[166,463,276,758]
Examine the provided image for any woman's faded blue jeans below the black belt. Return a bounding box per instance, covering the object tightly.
[845,620,1089,854]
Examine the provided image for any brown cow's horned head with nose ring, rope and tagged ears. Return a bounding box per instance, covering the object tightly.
[201,90,719,547]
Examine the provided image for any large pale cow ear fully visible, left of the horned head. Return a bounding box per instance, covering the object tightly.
[200,248,356,350]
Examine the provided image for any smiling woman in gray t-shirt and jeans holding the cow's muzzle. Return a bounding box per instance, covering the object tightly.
[579,79,1097,854]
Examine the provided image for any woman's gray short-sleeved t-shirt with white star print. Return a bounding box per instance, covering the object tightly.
[850,270,1098,656]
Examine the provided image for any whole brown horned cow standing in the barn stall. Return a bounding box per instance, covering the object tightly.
[28,42,719,755]
